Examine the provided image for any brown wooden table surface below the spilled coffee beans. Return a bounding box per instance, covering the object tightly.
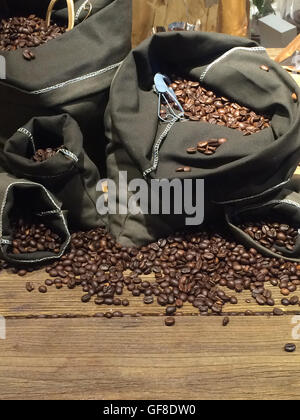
[0,46,300,400]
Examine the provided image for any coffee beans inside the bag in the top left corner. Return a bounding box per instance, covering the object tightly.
[0,15,66,60]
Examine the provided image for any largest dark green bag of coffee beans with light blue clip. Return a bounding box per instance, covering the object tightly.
[106,32,300,249]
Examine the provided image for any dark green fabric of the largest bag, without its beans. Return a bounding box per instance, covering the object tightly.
[106,32,300,248]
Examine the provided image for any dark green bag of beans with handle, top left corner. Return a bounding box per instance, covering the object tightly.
[0,0,131,171]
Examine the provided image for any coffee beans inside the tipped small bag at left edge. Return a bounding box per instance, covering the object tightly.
[11,219,61,254]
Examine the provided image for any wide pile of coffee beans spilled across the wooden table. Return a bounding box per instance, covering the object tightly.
[3,224,300,326]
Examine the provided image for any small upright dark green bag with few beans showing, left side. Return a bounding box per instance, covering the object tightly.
[3,114,103,230]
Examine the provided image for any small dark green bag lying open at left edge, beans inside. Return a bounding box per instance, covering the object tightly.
[0,173,70,265]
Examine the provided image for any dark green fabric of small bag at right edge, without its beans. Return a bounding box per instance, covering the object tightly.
[226,177,300,262]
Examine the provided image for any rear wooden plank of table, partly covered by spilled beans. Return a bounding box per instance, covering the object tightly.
[0,271,300,317]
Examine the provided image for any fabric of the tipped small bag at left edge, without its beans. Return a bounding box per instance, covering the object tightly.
[0,173,70,265]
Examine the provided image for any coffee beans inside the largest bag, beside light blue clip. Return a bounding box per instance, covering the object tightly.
[161,77,270,136]
